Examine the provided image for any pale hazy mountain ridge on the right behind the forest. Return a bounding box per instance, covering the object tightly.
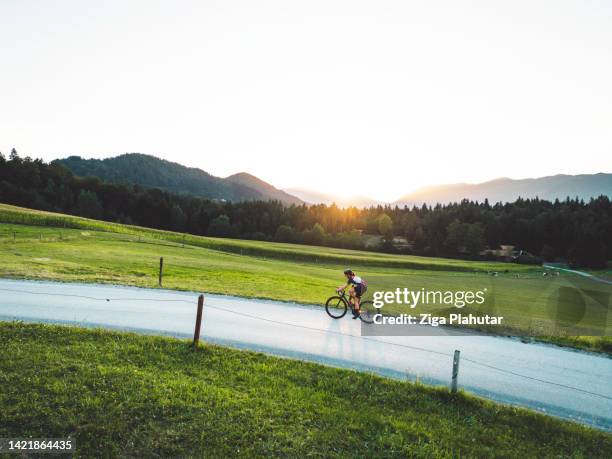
[393,173,612,206]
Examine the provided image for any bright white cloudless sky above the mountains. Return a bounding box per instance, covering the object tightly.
[0,0,612,200]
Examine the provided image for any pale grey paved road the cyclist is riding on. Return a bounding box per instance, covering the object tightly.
[0,280,612,431]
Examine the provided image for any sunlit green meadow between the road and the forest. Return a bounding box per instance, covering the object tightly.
[0,205,612,352]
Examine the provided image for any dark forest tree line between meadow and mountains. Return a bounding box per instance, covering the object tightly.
[0,149,612,268]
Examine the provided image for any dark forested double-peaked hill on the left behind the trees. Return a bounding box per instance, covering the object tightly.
[56,153,302,204]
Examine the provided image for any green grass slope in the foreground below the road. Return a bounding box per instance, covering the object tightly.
[0,322,612,458]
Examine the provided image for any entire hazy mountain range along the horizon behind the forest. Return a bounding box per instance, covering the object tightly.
[55,153,612,207]
